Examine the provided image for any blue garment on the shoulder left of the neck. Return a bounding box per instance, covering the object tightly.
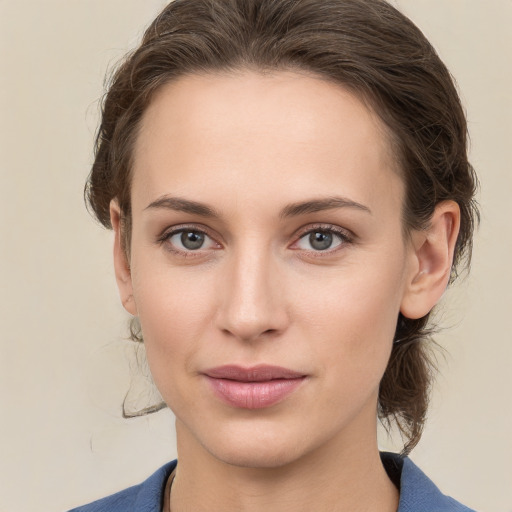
[69,461,176,512]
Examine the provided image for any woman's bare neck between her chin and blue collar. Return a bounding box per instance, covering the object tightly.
[171,423,399,512]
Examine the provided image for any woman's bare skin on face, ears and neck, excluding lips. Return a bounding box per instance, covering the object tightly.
[111,71,459,512]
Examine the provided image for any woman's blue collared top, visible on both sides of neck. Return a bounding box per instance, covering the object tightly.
[69,453,474,512]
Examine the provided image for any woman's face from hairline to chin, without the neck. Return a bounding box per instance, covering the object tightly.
[114,71,420,467]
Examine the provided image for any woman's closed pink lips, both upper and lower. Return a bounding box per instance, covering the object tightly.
[204,365,307,409]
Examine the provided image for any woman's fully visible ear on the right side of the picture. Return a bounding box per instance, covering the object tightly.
[400,201,460,319]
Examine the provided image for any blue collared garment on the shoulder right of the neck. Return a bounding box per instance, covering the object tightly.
[381,453,475,512]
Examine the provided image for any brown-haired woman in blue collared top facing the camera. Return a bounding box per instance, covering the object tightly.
[70,0,477,512]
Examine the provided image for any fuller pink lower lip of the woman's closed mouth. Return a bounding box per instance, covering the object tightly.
[206,376,305,409]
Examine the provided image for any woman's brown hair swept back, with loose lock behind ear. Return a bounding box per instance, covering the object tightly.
[86,0,478,453]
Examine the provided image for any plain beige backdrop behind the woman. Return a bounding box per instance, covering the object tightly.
[0,0,512,512]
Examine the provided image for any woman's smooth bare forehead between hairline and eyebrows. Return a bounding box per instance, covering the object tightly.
[132,71,401,213]
